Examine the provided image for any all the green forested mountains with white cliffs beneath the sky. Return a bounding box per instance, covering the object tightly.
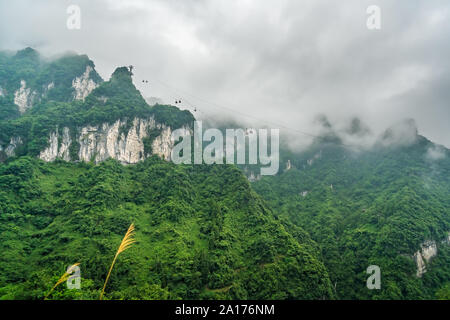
[0,48,450,299]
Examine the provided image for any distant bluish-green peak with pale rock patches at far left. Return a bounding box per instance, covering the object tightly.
[0,48,102,119]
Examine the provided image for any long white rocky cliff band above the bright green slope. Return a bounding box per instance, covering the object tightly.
[39,118,190,164]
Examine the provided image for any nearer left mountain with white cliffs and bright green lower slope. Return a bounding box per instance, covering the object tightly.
[0,49,335,299]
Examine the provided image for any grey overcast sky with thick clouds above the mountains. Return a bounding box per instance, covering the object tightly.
[0,0,450,147]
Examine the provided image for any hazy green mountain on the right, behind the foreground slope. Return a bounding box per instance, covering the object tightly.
[252,132,450,299]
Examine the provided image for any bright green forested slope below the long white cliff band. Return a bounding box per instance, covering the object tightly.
[0,157,333,299]
